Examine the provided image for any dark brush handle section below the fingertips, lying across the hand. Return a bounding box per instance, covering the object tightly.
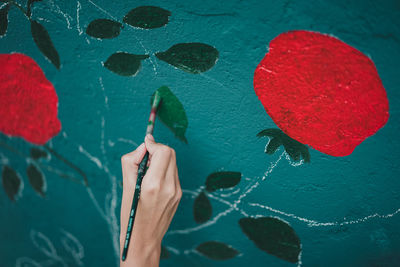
[122,152,149,261]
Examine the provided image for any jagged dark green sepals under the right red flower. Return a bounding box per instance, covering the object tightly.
[257,129,311,163]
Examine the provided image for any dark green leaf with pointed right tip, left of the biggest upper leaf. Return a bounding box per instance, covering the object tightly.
[104,52,149,76]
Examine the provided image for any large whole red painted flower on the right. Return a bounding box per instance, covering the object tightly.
[254,31,389,156]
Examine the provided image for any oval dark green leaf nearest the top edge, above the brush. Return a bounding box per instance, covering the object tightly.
[124,6,171,29]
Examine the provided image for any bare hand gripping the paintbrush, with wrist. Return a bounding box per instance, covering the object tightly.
[120,135,182,267]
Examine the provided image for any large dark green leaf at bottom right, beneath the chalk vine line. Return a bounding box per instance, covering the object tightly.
[239,217,301,263]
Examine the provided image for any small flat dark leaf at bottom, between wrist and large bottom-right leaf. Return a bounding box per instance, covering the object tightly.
[196,241,239,260]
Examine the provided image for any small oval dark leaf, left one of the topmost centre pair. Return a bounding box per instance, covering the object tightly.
[86,19,122,39]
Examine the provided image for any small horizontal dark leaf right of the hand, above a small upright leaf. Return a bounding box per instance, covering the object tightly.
[206,171,242,192]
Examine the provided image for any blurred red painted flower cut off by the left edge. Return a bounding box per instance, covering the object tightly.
[0,54,61,145]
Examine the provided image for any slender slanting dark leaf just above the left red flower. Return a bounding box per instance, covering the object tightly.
[31,20,60,69]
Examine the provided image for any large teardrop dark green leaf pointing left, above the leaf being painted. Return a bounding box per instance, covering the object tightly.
[156,43,219,74]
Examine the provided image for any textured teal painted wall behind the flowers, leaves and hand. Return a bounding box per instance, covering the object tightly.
[0,0,400,266]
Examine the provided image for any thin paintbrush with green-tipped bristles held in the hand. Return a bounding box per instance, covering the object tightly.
[122,90,161,261]
